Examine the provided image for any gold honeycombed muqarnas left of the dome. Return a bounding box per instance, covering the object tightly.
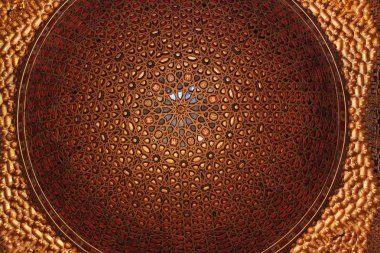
[0,1,75,252]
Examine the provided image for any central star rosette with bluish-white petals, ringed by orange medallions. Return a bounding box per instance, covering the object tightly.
[134,71,233,148]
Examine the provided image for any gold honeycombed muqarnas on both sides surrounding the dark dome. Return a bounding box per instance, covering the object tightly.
[0,0,380,252]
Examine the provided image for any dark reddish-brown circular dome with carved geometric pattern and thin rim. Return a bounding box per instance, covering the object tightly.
[18,0,345,252]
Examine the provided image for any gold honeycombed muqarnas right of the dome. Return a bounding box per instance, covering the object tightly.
[292,1,379,252]
